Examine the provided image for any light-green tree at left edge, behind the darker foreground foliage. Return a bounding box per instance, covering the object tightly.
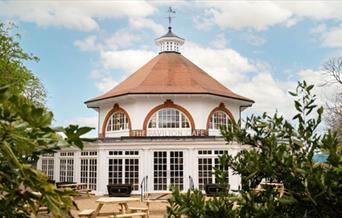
[0,22,46,107]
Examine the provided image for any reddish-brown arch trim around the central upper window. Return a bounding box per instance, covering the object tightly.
[143,100,195,132]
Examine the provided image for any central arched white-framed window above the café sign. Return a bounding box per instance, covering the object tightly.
[148,108,190,129]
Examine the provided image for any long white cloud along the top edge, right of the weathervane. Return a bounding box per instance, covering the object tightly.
[195,1,342,31]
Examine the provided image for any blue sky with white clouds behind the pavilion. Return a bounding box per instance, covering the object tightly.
[0,0,342,135]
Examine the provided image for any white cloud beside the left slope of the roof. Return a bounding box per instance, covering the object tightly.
[74,29,156,92]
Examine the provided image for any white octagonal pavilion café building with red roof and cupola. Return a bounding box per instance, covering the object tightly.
[38,24,254,195]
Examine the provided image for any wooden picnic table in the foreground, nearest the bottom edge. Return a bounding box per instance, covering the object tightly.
[91,197,140,217]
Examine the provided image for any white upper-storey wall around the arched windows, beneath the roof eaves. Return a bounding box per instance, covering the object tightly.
[99,96,241,137]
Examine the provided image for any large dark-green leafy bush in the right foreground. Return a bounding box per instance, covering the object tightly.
[168,81,342,217]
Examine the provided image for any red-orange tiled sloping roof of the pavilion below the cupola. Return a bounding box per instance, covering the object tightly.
[86,52,254,103]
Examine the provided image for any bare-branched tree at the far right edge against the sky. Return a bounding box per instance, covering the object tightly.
[323,57,342,144]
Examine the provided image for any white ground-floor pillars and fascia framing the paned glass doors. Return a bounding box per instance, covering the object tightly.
[37,139,249,195]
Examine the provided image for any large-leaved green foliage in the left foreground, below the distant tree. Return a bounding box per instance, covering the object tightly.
[0,87,91,217]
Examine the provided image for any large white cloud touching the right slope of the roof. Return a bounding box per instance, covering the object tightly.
[182,42,337,119]
